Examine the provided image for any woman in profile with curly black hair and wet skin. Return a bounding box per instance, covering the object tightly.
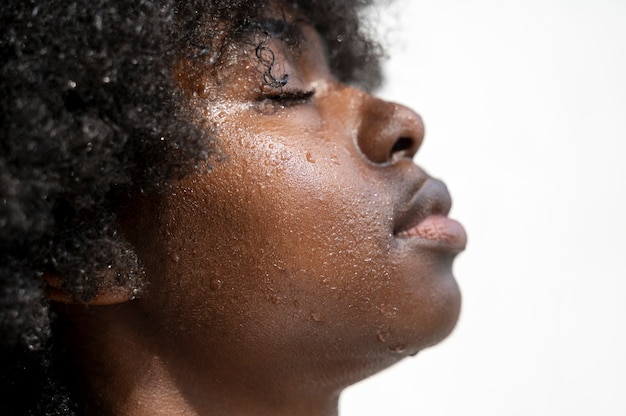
[0,0,465,415]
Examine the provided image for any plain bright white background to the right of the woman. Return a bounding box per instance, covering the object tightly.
[340,0,626,416]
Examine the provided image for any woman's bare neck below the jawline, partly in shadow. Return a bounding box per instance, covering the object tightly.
[56,306,341,416]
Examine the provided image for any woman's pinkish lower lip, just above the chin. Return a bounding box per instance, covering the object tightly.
[398,215,467,252]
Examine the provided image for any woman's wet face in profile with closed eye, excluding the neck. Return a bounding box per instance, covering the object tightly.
[122,19,465,384]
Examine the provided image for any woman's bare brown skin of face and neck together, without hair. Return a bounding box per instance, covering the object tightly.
[51,16,465,416]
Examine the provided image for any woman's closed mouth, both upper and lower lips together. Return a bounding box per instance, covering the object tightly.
[393,178,467,253]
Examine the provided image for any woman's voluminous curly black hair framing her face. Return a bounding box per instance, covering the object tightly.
[0,0,382,415]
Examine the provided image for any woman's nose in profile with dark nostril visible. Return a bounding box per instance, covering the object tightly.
[357,95,424,164]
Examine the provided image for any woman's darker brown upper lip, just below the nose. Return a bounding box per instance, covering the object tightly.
[393,177,452,235]
